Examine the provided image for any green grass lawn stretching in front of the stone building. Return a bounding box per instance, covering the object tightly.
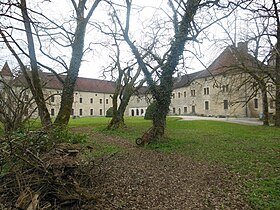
[70,117,280,209]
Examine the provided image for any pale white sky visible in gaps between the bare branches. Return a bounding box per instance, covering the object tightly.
[0,0,276,79]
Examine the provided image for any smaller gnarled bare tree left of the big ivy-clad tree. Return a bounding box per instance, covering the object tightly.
[95,14,147,129]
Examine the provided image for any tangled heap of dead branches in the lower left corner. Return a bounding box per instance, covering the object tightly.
[0,133,98,210]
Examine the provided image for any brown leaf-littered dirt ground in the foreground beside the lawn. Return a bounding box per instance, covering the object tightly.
[80,130,250,210]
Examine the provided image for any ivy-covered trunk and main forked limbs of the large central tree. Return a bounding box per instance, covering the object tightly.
[124,0,200,141]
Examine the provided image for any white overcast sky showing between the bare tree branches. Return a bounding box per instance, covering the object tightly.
[0,0,276,79]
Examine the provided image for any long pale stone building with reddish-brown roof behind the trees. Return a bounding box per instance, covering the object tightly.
[0,43,275,117]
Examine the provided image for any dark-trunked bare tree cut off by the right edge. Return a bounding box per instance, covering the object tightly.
[237,0,280,127]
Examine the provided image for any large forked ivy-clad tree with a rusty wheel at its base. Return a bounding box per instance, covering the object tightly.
[109,0,238,140]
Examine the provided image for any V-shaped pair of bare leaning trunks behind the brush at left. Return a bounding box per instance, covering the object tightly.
[0,0,101,126]
